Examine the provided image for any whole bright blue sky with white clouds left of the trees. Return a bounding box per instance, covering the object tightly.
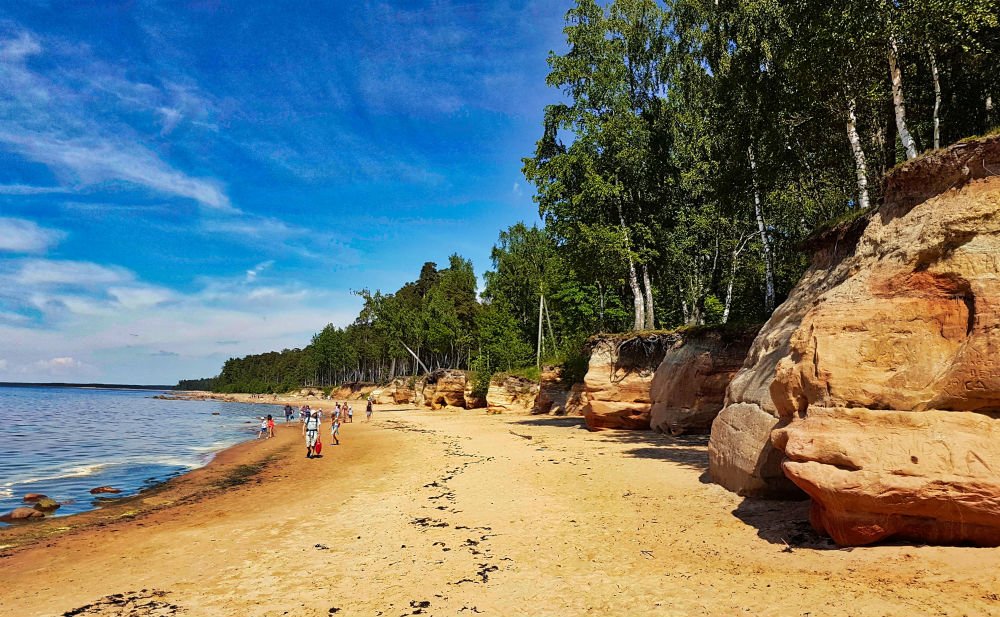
[0,0,571,383]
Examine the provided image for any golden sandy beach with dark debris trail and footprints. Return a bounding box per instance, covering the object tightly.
[0,409,1000,616]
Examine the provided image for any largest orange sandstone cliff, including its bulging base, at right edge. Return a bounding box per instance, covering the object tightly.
[709,138,1000,545]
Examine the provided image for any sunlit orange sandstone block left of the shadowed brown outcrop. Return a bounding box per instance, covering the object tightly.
[582,335,676,430]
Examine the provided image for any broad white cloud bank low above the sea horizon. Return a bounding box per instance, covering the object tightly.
[0,254,358,383]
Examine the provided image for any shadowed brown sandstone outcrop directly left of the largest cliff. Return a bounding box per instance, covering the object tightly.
[650,328,756,435]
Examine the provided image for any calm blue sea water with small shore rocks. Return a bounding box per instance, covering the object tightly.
[0,387,270,525]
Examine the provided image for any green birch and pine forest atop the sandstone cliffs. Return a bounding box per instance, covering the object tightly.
[179,0,1000,394]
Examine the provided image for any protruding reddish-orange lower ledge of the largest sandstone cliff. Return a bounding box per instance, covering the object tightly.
[774,407,1000,546]
